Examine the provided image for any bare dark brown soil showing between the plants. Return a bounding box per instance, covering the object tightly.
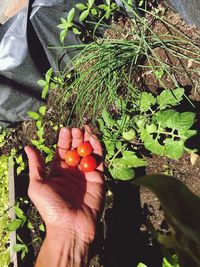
[2,2,200,267]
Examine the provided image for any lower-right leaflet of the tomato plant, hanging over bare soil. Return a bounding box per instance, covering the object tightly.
[164,139,184,160]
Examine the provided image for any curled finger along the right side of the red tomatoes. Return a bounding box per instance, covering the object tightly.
[84,125,104,171]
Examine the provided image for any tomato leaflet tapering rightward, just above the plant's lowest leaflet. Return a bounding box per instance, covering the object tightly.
[122,151,147,168]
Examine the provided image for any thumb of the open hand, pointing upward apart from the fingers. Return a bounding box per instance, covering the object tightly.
[24,146,46,182]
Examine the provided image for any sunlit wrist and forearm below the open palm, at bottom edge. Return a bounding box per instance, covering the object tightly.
[35,231,89,267]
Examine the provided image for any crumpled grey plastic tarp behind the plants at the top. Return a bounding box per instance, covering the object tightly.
[0,0,200,126]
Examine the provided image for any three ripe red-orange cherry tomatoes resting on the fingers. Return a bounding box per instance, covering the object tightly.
[65,142,97,172]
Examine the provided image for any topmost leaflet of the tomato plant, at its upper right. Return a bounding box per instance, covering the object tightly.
[157,88,185,109]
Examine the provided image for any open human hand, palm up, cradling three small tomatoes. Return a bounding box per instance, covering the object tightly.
[25,126,104,243]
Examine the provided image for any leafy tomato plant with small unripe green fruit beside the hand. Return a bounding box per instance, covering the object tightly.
[98,88,197,180]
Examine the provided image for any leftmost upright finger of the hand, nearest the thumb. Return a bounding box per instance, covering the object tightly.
[54,128,72,161]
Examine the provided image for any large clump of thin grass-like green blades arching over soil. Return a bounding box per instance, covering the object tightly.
[55,1,200,124]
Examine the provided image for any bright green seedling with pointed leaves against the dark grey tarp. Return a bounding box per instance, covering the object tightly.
[58,8,81,44]
